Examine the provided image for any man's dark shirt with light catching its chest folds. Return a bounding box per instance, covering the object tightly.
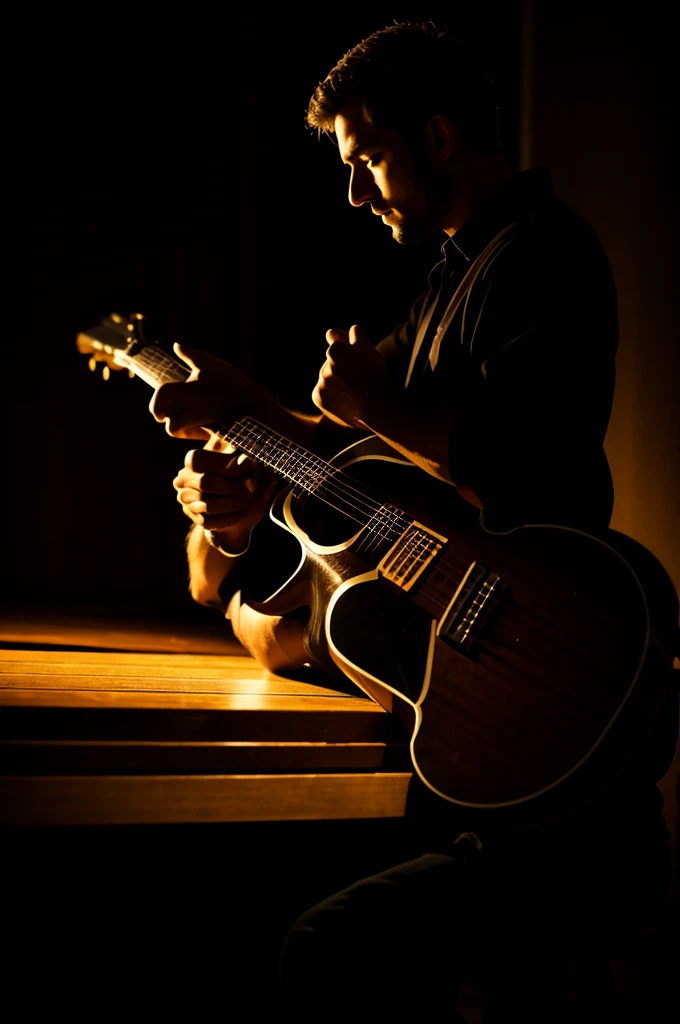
[378,168,618,530]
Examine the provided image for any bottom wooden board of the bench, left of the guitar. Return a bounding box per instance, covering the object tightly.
[0,772,411,825]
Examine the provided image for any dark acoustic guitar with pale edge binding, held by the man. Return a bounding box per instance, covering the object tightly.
[77,313,678,822]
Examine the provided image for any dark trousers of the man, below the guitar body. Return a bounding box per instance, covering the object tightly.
[280,791,671,1021]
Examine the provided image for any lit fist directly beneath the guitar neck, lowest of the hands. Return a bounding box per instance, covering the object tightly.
[172,449,278,551]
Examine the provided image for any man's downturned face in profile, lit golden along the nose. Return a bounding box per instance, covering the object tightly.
[335,99,450,245]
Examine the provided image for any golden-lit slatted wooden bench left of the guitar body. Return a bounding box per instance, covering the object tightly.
[0,616,412,826]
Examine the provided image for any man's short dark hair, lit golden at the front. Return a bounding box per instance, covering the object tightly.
[305,22,501,157]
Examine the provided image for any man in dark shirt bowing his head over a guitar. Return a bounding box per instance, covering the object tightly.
[152,25,673,1016]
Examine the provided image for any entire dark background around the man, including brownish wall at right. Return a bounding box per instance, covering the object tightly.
[0,6,680,1019]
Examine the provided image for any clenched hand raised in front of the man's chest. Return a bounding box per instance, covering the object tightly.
[311,325,393,429]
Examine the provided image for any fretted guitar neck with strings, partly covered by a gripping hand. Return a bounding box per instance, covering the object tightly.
[122,345,399,525]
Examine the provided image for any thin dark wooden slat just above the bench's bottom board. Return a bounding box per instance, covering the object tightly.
[0,739,412,775]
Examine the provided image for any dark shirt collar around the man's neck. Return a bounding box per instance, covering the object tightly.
[441,167,555,262]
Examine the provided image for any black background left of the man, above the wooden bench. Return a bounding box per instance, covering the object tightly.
[0,0,520,622]
